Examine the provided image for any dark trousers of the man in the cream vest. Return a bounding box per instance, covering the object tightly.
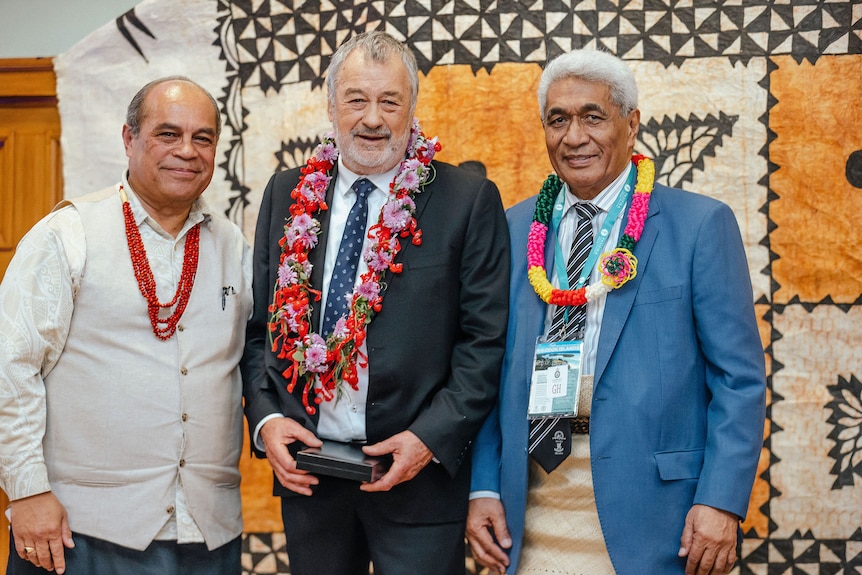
[6,533,242,575]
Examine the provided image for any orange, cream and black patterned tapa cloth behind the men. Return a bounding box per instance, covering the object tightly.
[55,0,862,574]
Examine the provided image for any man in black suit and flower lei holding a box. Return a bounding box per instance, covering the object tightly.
[242,32,509,575]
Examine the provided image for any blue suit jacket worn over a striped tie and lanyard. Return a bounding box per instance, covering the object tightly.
[471,185,766,575]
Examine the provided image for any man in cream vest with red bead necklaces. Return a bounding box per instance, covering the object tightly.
[0,77,252,575]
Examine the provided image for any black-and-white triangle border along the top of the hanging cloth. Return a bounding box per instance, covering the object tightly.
[213,0,862,92]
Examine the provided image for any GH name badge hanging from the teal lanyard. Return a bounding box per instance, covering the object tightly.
[528,337,584,419]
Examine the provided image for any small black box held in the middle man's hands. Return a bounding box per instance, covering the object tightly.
[296,439,392,482]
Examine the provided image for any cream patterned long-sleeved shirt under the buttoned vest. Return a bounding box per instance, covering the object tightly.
[0,176,252,543]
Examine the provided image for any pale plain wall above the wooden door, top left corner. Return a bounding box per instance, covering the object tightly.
[0,0,141,58]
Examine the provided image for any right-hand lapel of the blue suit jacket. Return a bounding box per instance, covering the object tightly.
[594,191,661,385]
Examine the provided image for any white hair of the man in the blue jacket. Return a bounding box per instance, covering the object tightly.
[538,50,638,122]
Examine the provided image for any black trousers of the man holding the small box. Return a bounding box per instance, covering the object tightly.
[281,476,466,575]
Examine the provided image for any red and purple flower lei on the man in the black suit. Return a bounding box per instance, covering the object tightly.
[267,119,440,414]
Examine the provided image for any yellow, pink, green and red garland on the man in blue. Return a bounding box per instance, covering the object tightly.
[527,154,655,306]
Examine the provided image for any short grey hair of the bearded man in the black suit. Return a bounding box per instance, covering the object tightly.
[326,30,419,114]
